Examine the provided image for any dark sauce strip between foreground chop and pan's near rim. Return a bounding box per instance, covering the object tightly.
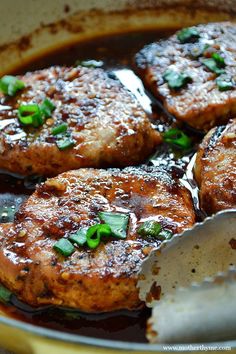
[0,299,151,343]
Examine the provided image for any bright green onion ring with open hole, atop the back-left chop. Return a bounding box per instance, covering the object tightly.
[18,104,44,128]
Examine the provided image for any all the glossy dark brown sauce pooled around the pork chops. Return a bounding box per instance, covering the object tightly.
[0,30,201,342]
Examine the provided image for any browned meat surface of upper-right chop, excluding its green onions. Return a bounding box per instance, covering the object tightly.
[136,22,236,130]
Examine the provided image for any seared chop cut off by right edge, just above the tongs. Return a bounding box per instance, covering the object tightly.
[195,119,236,214]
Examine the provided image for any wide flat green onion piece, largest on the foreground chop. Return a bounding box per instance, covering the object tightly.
[98,211,129,239]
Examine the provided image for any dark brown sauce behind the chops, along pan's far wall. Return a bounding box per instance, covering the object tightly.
[15,29,173,74]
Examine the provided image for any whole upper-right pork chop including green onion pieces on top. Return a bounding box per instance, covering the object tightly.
[136,22,236,130]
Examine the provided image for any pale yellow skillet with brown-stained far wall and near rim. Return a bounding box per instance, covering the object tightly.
[0,0,236,354]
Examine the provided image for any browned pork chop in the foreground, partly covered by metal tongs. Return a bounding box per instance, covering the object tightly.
[0,167,195,312]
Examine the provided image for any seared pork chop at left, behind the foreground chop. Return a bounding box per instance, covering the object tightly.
[0,67,161,176]
